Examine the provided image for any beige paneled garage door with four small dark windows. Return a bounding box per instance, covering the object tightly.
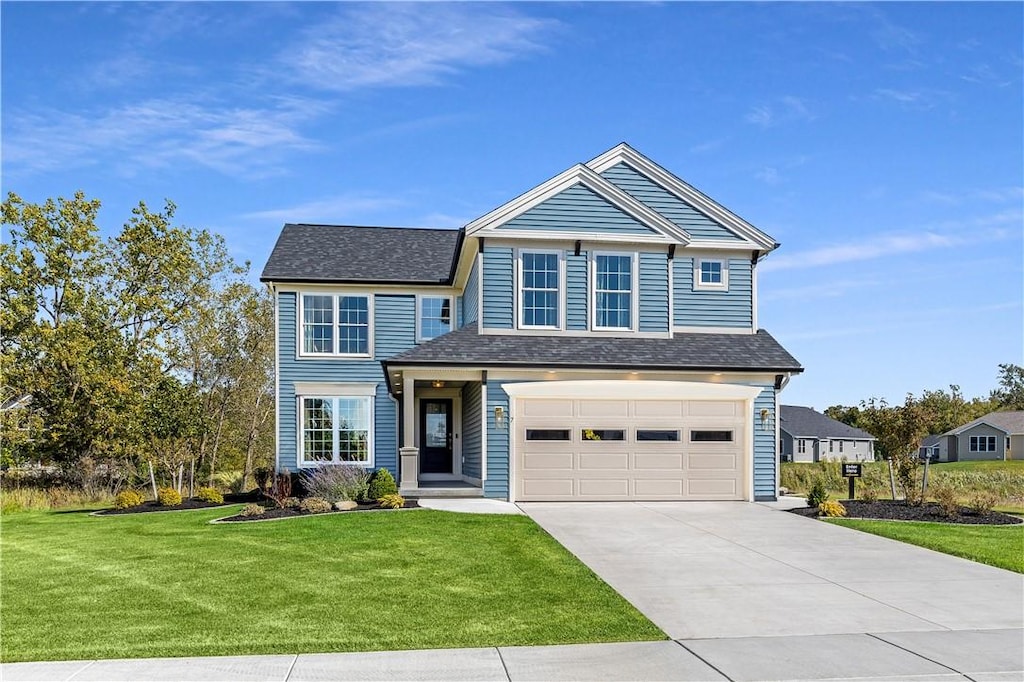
[513,398,745,502]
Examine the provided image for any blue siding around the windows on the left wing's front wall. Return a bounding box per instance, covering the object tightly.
[278,292,416,477]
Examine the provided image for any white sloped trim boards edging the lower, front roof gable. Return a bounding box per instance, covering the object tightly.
[466,164,691,246]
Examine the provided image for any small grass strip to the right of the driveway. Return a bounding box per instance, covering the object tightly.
[829,519,1024,573]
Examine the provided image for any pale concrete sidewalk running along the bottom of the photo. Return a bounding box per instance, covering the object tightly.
[0,629,1024,682]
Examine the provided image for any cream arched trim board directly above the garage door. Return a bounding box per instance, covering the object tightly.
[502,380,762,400]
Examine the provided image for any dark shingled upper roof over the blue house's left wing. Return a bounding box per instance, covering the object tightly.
[260,224,462,284]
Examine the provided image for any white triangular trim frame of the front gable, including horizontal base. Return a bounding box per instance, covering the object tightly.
[466,164,690,245]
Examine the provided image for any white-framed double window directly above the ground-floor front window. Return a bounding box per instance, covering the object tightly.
[301,294,370,355]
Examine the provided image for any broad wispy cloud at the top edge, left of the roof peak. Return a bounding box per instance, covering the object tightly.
[280,3,558,91]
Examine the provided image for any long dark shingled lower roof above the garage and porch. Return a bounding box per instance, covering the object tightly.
[384,324,803,372]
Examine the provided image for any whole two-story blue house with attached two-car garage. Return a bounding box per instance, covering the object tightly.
[261,144,803,501]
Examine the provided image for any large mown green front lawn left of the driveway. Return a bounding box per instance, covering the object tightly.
[0,508,666,662]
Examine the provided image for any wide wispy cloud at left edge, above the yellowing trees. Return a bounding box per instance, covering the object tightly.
[3,97,325,176]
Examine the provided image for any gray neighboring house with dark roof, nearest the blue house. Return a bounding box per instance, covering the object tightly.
[778,404,874,462]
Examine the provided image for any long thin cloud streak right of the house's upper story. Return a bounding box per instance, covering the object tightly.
[760,215,1024,272]
